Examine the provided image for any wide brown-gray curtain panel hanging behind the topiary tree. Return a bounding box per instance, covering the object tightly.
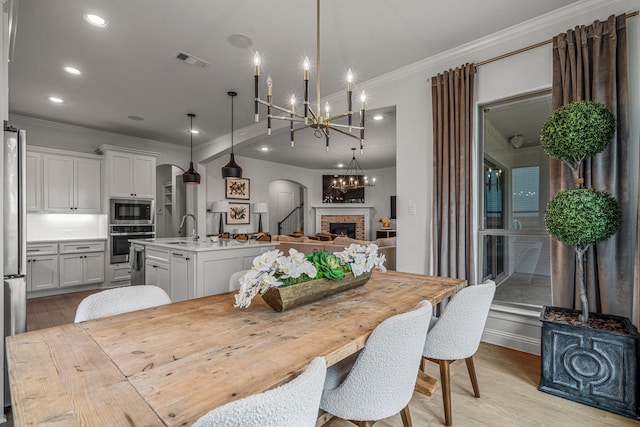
[550,15,637,317]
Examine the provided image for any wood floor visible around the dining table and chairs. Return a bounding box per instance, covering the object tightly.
[22,291,640,427]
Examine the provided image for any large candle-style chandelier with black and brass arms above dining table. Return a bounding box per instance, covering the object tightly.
[253,0,366,152]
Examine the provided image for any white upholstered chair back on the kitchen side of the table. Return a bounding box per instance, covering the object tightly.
[75,285,171,323]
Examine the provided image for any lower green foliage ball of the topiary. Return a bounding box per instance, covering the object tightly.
[544,188,621,247]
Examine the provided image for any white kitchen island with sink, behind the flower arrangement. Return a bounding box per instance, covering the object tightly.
[131,238,278,302]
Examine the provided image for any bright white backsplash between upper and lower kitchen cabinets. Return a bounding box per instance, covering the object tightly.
[27,214,108,242]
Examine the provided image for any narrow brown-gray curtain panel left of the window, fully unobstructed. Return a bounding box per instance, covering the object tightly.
[431,64,475,283]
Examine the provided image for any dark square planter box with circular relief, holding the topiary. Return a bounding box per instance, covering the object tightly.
[538,307,640,419]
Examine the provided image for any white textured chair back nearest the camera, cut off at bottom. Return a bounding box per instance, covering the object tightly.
[193,357,327,427]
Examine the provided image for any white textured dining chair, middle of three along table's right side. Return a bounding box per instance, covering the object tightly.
[320,301,432,427]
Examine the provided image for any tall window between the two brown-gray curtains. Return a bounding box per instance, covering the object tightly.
[478,92,551,306]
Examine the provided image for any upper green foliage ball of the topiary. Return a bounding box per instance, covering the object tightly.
[540,101,616,162]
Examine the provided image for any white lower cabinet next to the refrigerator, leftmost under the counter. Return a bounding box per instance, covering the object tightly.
[26,243,58,291]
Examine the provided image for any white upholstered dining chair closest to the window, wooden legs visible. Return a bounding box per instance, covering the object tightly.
[416,281,496,426]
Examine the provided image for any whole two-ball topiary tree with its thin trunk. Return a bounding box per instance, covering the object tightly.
[540,101,621,322]
